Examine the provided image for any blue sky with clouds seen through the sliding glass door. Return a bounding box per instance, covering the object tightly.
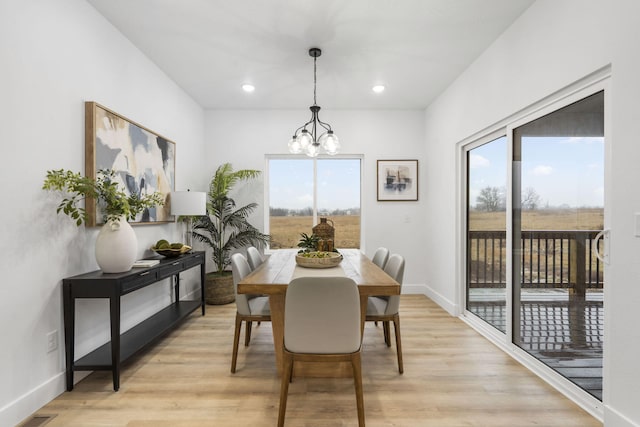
[469,137,604,207]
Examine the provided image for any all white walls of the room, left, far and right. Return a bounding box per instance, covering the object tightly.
[6,0,640,427]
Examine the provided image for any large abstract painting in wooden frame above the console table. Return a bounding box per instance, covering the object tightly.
[85,102,176,226]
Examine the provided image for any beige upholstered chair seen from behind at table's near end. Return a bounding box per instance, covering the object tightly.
[278,277,364,427]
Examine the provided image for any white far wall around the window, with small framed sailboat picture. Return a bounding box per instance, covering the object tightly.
[205,109,424,290]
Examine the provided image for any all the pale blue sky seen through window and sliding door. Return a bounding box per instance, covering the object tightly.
[269,137,604,210]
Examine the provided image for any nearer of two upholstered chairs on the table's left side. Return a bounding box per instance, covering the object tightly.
[231,253,271,373]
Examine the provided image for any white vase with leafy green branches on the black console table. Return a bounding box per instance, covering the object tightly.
[42,169,164,273]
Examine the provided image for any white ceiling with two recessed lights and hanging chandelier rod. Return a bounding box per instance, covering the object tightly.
[87,0,534,109]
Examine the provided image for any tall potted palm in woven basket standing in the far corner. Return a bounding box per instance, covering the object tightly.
[193,163,270,304]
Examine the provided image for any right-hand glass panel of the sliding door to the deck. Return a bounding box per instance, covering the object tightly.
[511,92,604,400]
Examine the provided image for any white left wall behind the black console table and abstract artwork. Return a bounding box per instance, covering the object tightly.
[0,0,207,426]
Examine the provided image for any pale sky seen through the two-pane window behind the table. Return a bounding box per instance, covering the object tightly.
[269,158,360,210]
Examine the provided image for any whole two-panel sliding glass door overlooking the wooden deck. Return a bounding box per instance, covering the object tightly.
[465,91,605,400]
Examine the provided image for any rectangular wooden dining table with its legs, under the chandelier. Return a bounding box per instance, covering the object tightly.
[237,249,400,377]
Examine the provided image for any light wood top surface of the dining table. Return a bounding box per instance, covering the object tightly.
[238,249,400,296]
